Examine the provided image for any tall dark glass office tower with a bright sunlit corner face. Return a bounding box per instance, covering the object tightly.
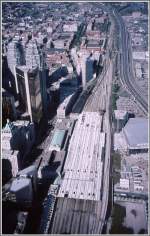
[16,66,43,123]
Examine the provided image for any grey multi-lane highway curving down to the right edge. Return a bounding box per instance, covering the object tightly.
[112,9,148,113]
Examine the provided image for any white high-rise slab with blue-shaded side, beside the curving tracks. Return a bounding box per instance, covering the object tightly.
[81,54,93,87]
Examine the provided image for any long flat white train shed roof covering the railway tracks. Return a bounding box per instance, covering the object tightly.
[58,112,105,201]
